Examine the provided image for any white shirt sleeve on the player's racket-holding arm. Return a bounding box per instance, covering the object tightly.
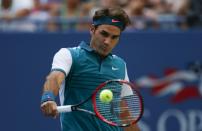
[51,48,72,76]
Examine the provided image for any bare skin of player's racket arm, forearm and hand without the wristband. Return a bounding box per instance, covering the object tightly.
[41,71,65,117]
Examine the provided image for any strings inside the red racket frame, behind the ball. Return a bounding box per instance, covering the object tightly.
[96,82,142,125]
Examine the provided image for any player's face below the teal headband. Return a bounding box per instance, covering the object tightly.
[90,25,121,57]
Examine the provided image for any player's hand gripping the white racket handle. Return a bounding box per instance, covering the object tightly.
[41,101,58,118]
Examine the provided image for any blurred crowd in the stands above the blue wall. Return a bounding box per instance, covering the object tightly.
[0,0,202,32]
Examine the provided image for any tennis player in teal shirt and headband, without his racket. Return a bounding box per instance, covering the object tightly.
[41,8,139,131]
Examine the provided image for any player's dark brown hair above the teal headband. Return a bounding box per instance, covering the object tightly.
[93,7,131,31]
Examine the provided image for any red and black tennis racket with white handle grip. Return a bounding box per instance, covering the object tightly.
[57,80,143,127]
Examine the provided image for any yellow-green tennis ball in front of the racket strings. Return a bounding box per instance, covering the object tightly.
[100,89,113,103]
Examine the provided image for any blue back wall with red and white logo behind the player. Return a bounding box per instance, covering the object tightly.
[0,31,202,131]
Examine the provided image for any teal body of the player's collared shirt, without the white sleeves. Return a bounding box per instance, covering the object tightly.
[61,42,126,131]
